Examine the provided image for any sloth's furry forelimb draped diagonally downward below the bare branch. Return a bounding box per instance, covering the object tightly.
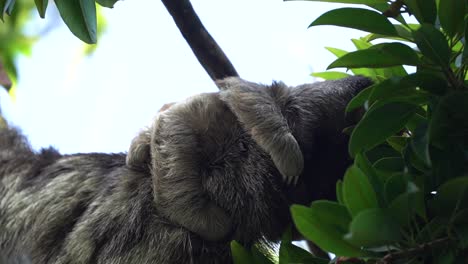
[217,77,304,183]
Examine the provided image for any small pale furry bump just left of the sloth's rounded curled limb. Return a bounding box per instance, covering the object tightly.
[126,129,151,171]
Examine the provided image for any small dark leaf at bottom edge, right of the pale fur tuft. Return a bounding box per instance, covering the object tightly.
[279,243,329,264]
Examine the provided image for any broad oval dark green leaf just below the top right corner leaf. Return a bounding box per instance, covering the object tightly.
[413,24,450,67]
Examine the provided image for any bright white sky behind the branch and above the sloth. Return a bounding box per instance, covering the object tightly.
[0,0,365,153]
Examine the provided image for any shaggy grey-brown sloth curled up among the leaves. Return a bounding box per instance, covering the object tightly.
[0,77,371,264]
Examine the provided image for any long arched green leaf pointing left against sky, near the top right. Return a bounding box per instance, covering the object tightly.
[309,8,397,36]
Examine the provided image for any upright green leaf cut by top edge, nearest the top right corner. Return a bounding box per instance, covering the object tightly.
[438,0,468,38]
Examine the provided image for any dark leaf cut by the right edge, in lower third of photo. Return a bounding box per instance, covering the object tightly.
[429,177,468,216]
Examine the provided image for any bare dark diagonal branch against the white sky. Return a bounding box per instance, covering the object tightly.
[161,0,239,84]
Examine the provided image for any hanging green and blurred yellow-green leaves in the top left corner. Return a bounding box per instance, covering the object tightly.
[0,0,108,90]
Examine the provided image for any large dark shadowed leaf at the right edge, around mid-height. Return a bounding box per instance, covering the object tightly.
[429,91,468,148]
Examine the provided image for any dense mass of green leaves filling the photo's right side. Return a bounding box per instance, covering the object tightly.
[233,0,468,264]
